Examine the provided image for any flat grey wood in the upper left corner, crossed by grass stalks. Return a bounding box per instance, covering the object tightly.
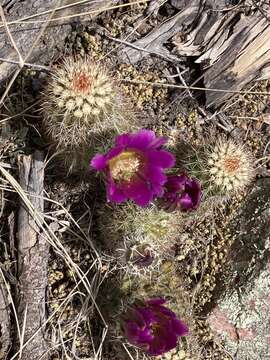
[0,0,117,85]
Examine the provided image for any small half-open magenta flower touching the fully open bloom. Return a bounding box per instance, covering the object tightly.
[162,174,202,211]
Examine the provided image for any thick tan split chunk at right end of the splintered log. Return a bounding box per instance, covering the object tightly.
[189,4,270,107]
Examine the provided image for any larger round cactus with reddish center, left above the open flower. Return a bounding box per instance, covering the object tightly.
[41,57,136,172]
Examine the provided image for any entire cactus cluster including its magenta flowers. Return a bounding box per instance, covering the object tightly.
[40,54,254,355]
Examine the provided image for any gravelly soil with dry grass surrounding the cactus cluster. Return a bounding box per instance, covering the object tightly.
[0,1,270,360]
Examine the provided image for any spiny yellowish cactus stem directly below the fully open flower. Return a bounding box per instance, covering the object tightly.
[99,203,183,255]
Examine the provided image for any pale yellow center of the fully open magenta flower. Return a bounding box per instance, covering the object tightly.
[109,151,142,181]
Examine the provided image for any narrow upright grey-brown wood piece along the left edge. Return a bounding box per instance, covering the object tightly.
[17,151,49,360]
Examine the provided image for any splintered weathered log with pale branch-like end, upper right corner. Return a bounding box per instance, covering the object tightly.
[120,0,270,107]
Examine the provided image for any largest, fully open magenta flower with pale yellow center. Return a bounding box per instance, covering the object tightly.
[91,130,175,207]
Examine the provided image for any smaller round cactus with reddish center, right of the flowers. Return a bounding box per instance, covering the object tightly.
[184,137,255,199]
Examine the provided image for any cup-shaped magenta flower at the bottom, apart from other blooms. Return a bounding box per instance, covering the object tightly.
[122,298,188,356]
